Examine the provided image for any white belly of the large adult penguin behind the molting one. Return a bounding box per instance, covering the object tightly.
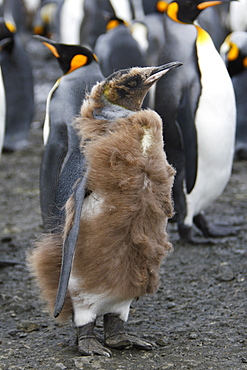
[185,34,236,225]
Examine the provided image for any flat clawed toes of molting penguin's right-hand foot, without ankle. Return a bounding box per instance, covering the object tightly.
[105,333,153,351]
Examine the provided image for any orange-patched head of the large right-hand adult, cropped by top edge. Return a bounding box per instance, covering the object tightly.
[167,0,234,24]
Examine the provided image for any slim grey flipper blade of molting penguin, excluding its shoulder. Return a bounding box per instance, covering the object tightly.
[54,166,87,317]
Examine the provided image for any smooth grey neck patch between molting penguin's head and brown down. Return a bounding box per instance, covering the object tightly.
[93,97,135,121]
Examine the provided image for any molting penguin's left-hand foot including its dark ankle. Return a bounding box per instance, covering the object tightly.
[77,322,111,357]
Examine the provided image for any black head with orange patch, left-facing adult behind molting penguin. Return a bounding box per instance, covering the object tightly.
[33,35,98,74]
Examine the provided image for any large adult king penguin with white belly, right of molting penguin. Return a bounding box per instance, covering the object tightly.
[155,0,236,243]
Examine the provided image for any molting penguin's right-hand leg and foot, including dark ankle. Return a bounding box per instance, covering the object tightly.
[104,313,153,351]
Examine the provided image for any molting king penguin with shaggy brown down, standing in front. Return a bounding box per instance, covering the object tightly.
[29,62,181,356]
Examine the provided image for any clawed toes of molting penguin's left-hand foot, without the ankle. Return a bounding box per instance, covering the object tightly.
[78,337,112,357]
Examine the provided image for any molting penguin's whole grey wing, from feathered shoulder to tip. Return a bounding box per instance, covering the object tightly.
[54,148,87,317]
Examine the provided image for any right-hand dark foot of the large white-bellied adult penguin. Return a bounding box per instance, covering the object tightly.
[193,212,238,238]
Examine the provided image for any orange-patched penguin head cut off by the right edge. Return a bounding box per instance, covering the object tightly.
[220,31,247,77]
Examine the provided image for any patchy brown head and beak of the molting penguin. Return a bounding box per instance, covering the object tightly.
[101,62,182,111]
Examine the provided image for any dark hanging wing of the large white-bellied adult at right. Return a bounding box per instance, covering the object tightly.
[177,92,197,194]
